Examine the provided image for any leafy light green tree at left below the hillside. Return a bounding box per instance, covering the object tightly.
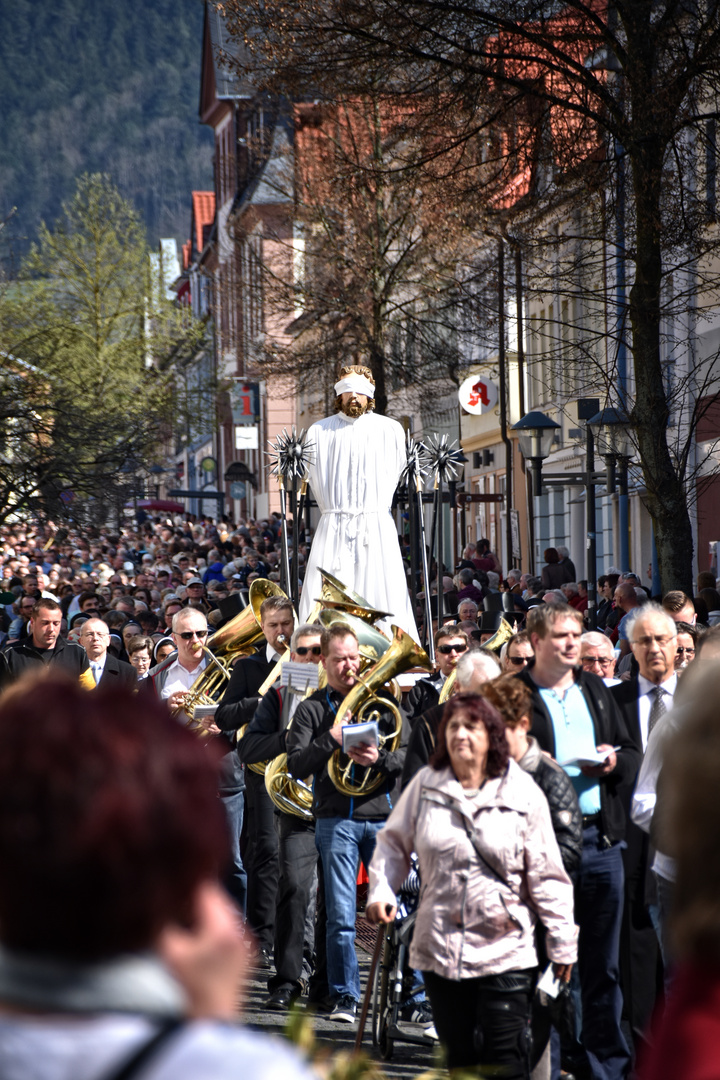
[0,174,199,519]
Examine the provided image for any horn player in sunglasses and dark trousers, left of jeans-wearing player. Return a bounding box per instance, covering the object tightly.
[237,623,327,1009]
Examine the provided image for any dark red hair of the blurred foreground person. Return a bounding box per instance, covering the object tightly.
[0,674,227,962]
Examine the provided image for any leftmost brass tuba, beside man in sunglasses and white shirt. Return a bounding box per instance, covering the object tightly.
[182,578,293,717]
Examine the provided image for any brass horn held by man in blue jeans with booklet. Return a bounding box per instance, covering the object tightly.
[327,626,433,798]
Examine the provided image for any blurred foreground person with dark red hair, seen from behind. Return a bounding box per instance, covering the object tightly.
[0,675,309,1080]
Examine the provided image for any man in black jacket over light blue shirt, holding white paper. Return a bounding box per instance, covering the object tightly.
[517,604,640,1080]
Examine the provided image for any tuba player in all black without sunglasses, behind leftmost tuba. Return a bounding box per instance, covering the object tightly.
[215,596,295,968]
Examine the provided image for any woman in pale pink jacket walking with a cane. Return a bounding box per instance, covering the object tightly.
[367,693,576,1080]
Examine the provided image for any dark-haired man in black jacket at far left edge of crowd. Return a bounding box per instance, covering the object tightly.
[0,596,89,686]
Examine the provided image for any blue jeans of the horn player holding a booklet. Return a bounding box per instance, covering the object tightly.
[315,818,384,1001]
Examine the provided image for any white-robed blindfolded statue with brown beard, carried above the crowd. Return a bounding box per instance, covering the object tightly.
[299,365,418,640]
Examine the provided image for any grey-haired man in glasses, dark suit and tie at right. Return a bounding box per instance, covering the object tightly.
[611,603,678,1054]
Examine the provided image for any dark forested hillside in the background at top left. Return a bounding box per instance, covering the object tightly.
[0,0,212,255]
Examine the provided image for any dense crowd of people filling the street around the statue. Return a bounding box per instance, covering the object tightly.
[0,515,720,1080]
